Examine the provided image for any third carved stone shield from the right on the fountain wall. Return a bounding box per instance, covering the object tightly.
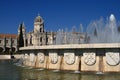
[64,52,75,65]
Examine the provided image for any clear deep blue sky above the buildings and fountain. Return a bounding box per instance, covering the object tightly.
[0,0,120,34]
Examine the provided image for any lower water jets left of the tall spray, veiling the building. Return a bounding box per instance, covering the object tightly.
[54,25,84,45]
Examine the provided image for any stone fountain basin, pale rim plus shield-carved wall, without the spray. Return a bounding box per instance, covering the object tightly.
[20,43,120,72]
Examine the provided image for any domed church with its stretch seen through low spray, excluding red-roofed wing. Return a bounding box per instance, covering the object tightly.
[18,16,85,46]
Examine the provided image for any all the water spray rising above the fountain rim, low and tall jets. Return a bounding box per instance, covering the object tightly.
[55,14,120,45]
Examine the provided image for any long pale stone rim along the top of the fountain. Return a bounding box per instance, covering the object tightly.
[19,43,120,50]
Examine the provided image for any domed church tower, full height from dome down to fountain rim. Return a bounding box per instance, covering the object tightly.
[32,16,47,46]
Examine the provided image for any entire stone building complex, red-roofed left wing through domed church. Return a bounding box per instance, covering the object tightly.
[0,16,85,52]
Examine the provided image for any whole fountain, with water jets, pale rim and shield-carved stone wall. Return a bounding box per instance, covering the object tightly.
[20,14,120,74]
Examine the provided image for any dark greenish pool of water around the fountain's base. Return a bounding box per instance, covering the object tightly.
[0,60,120,80]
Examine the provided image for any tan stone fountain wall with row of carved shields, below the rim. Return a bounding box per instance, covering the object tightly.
[20,51,120,72]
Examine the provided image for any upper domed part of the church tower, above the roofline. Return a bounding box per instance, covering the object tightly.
[34,15,44,33]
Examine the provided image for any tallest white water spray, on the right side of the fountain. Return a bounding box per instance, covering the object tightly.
[87,14,120,43]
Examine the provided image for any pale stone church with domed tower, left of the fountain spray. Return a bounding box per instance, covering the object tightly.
[18,16,54,46]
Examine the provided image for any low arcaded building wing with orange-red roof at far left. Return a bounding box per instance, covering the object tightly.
[0,34,18,53]
